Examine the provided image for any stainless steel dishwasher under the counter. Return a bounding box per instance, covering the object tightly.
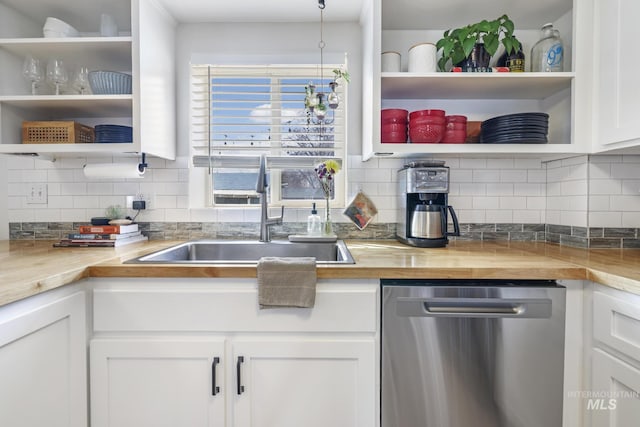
[381,279,565,427]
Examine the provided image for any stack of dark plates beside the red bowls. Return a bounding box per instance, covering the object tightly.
[480,113,549,144]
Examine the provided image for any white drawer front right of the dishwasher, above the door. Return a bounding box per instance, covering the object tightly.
[593,292,640,361]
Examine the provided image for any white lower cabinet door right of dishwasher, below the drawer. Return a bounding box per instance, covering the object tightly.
[585,349,640,427]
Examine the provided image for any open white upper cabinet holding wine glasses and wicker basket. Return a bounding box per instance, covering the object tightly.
[0,0,176,159]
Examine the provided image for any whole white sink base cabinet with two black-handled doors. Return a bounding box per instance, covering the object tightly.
[90,279,379,427]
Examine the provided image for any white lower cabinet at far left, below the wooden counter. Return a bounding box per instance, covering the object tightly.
[0,287,87,427]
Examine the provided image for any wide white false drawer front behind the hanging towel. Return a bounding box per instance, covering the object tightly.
[93,279,378,333]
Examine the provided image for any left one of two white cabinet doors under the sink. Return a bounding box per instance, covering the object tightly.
[90,339,225,427]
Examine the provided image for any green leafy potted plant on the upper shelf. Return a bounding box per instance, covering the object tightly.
[436,15,522,71]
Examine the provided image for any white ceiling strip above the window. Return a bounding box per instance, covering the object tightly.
[158,0,370,23]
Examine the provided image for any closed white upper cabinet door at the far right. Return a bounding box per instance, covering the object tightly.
[594,0,640,150]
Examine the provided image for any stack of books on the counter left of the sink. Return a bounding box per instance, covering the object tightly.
[53,224,147,248]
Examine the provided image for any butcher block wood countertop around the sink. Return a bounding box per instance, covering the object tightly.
[0,240,640,305]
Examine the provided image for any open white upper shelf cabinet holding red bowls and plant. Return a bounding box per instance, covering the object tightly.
[361,0,593,158]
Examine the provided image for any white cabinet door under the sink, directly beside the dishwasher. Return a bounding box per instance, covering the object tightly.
[232,338,376,427]
